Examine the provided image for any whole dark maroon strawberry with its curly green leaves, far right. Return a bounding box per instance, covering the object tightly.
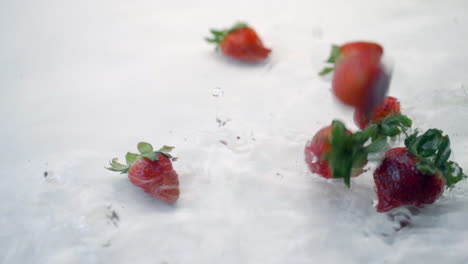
[374,129,466,212]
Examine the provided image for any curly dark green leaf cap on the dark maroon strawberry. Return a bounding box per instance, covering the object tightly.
[405,128,467,188]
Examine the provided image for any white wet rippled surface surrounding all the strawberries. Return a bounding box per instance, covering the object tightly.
[0,0,468,264]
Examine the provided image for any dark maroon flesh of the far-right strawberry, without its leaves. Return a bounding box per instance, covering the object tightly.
[374,148,445,212]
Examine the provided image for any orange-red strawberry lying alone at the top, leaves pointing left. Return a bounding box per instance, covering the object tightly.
[206,23,271,63]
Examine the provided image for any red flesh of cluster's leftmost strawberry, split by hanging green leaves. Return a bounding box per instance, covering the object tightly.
[304,125,367,178]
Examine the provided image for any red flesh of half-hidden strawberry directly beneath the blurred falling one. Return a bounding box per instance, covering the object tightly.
[354,96,400,129]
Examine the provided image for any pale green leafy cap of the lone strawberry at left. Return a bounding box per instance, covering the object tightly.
[106,142,174,174]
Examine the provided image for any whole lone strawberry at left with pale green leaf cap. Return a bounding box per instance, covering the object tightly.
[107,142,180,203]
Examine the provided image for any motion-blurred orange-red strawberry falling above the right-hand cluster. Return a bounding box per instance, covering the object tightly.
[320,42,391,113]
